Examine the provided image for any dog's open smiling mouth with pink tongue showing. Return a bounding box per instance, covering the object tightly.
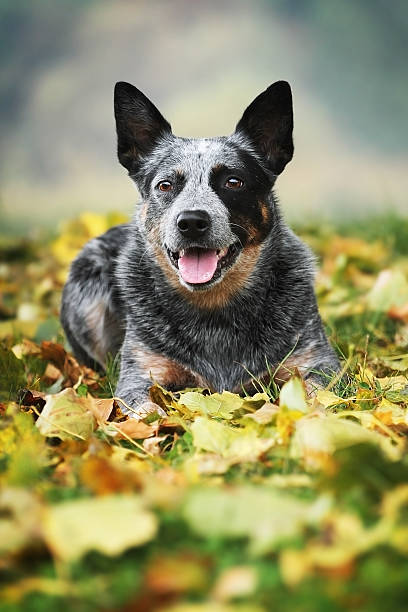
[166,242,241,288]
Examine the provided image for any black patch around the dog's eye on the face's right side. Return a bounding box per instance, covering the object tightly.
[209,147,274,247]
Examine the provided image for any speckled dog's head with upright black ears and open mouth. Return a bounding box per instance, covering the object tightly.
[115,81,293,291]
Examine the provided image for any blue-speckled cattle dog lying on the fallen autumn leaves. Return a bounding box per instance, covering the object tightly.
[61,81,339,418]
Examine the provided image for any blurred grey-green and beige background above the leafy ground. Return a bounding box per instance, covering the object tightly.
[0,0,408,235]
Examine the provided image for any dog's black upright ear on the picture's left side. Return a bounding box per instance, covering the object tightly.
[114,81,171,174]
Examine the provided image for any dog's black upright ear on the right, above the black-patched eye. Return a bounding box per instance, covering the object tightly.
[236,81,293,174]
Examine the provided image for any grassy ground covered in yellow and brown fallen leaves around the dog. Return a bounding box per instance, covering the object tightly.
[0,214,408,612]
